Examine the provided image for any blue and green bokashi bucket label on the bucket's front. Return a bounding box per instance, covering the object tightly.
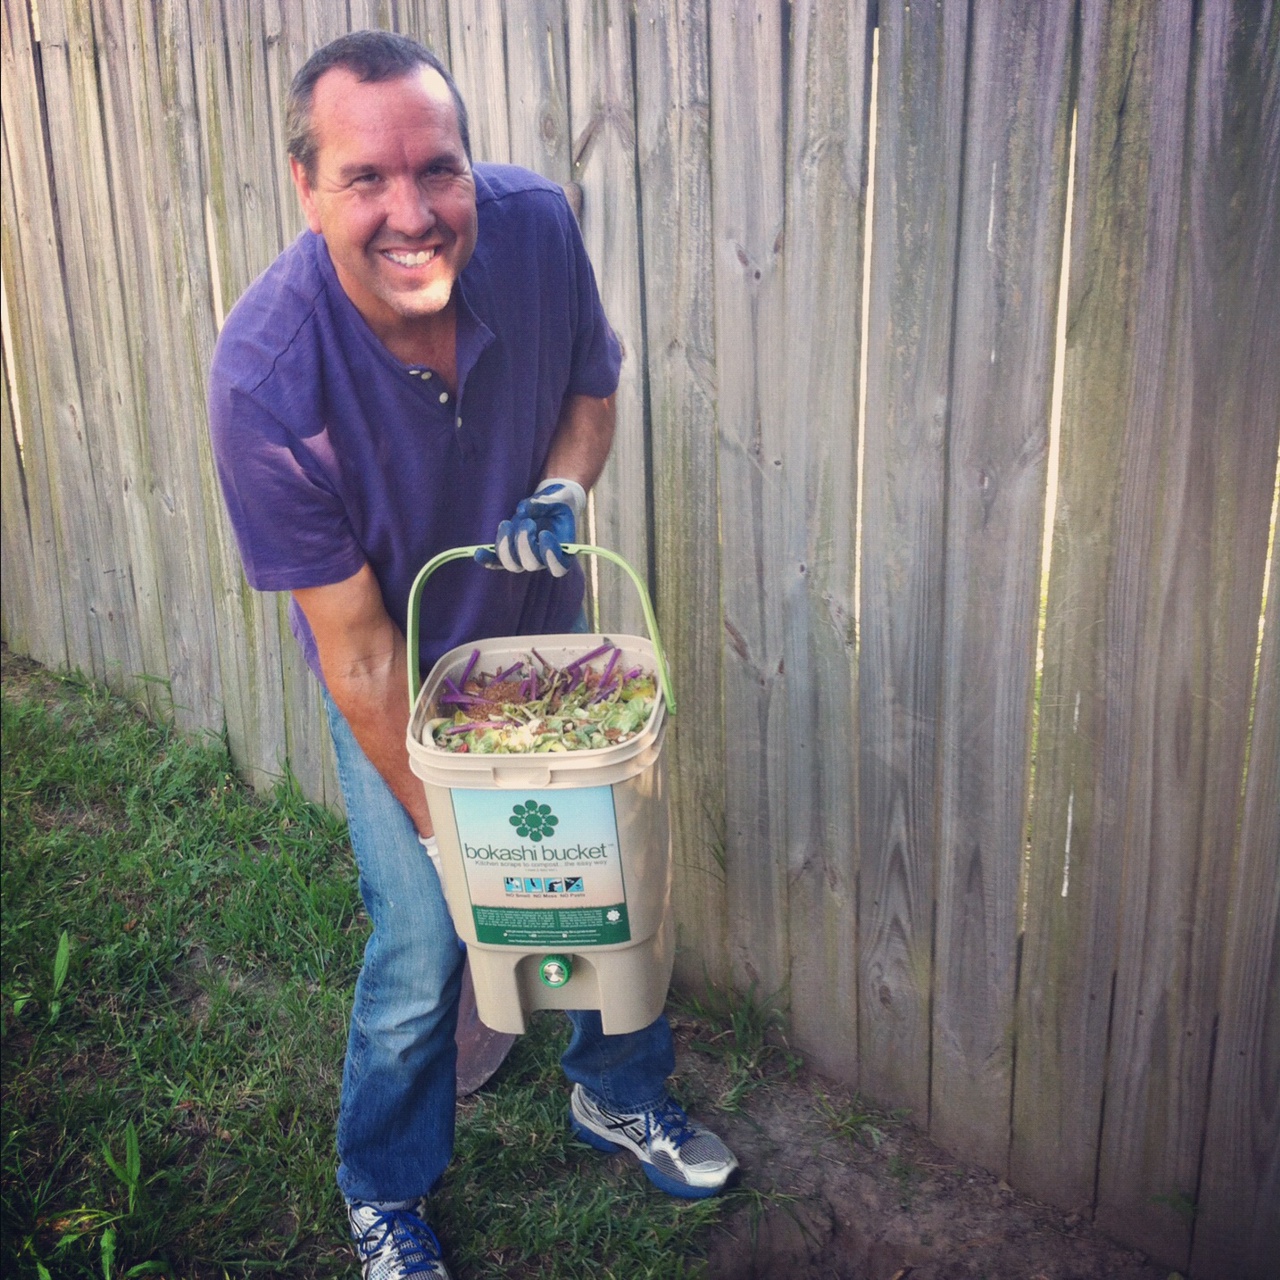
[449,787,631,950]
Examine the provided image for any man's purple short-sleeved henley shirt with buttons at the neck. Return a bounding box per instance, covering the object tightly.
[209,164,621,676]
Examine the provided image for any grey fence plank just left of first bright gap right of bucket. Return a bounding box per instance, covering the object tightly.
[778,4,872,1083]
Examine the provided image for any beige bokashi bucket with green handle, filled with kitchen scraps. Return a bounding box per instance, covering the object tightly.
[406,544,675,1036]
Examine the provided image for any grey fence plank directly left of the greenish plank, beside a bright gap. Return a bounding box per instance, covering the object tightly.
[929,0,1073,1174]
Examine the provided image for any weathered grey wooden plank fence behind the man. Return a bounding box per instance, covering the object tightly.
[3,0,1280,1280]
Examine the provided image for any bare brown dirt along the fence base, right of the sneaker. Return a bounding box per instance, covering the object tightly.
[673,1018,1170,1280]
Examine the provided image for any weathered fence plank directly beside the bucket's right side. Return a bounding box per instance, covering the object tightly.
[635,0,728,991]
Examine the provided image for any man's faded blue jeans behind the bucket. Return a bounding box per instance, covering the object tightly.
[324,692,675,1202]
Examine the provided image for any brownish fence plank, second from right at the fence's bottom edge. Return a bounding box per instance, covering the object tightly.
[1097,0,1280,1266]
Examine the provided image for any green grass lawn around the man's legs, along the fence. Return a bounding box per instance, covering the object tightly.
[0,675,731,1280]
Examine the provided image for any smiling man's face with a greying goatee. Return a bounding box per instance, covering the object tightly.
[292,67,476,340]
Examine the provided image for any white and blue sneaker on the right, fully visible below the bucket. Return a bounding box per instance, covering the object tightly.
[568,1084,737,1199]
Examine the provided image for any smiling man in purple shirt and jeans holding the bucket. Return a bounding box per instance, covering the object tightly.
[209,32,737,1280]
